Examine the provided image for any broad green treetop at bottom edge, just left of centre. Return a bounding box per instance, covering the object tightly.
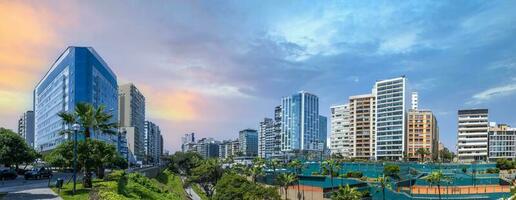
[212,173,280,200]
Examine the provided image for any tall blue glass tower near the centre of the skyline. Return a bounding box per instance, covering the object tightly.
[281,91,322,152]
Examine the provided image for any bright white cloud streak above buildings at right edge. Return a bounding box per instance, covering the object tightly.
[468,82,516,105]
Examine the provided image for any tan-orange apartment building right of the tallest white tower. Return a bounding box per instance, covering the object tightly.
[406,106,439,160]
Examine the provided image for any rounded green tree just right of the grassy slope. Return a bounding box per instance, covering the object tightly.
[188,159,224,197]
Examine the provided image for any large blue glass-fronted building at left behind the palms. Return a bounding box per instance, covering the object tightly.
[33,46,118,152]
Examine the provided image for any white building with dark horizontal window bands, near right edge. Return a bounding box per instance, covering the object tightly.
[457,109,489,162]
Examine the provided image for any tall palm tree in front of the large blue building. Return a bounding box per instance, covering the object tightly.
[57,103,118,188]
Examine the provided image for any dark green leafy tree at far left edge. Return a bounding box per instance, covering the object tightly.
[0,128,38,169]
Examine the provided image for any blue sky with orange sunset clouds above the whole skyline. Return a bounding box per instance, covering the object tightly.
[0,0,516,151]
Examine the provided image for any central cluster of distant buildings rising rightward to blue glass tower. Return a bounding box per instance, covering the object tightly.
[181,91,327,160]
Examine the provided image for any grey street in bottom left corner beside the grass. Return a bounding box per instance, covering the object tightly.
[0,173,71,200]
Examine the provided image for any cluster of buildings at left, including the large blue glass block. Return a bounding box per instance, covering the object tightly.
[18,47,163,164]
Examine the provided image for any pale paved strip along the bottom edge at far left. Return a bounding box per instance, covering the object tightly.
[4,187,62,200]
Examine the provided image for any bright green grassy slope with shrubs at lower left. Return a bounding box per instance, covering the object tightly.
[52,172,187,200]
